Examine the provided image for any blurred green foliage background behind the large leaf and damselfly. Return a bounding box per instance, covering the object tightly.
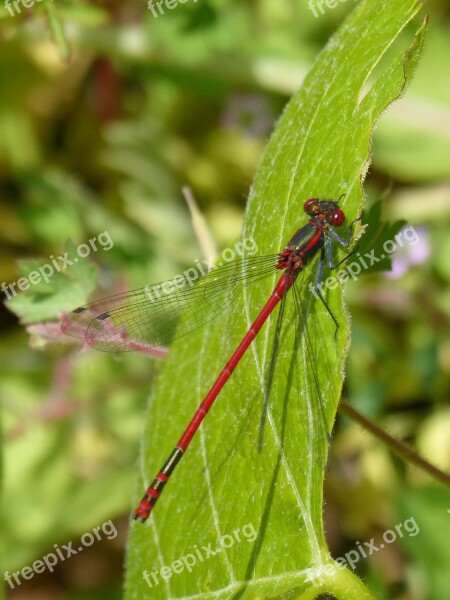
[0,0,450,600]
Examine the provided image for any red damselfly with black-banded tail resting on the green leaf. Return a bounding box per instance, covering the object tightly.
[62,198,355,522]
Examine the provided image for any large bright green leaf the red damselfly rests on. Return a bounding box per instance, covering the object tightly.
[126,0,425,600]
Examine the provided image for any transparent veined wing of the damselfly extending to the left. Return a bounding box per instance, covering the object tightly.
[61,254,278,352]
